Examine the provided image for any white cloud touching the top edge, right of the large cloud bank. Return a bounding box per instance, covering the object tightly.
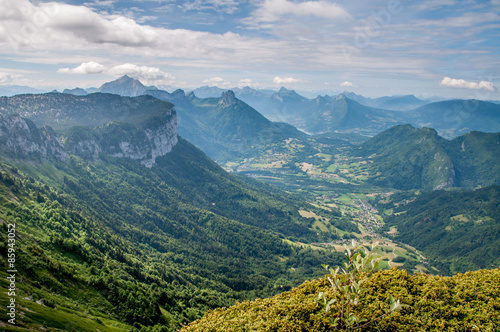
[253,0,350,22]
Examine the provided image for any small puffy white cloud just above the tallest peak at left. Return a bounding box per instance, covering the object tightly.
[57,61,175,84]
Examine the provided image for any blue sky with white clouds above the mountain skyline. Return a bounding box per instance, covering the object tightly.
[0,0,500,99]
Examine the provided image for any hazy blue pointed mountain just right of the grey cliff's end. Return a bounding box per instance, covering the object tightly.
[169,91,304,161]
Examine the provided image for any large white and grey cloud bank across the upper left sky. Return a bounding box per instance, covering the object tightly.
[0,0,279,62]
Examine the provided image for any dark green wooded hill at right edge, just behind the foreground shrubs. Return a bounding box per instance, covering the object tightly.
[377,186,500,275]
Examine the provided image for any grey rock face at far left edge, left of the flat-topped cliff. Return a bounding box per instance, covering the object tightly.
[0,114,68,160]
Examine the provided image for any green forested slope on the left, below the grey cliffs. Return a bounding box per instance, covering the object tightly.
[0,140,348,331]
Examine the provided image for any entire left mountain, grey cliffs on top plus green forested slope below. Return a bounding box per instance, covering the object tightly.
[0,94,346,331]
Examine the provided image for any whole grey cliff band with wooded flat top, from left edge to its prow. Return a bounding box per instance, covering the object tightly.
[0,93,177,167]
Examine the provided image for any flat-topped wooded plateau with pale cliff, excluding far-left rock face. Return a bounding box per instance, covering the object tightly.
[0,93,177,167]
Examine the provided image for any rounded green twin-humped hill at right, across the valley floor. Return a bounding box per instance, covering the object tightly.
[351,125,500,191]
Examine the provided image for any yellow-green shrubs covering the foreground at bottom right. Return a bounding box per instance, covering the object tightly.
[182,268,500,332]
